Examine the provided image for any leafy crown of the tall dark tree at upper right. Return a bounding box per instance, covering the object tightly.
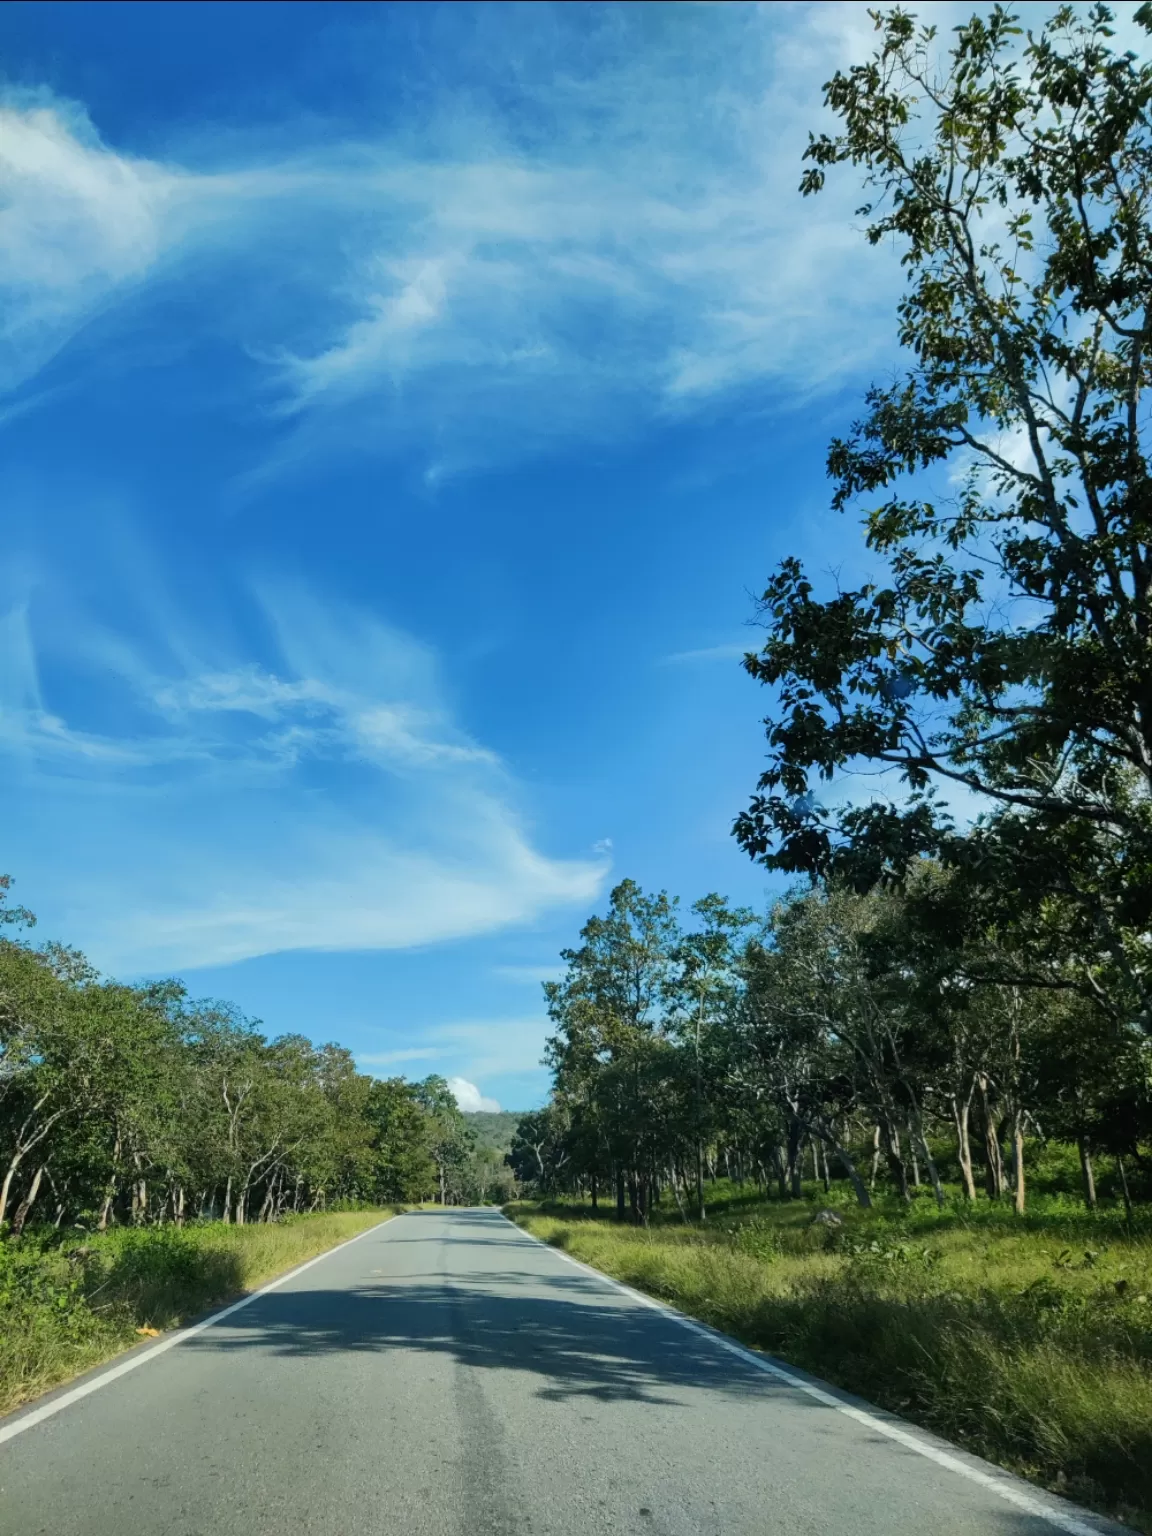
[737,5,1152,1028]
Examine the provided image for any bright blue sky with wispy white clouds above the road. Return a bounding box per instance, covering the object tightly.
[0,3,945,1107]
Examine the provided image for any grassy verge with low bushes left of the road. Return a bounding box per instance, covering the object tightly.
[0,1210,389,1413]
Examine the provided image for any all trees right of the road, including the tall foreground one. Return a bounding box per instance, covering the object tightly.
[515,5,1152,1220]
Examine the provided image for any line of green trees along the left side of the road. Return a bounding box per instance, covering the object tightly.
[0,877,508,1236]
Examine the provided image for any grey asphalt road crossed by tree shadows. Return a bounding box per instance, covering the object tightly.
[0,1210,1118,1536]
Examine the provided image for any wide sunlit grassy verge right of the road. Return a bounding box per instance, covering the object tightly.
[507,1187,1152,1531]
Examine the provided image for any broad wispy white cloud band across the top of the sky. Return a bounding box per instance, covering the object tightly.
[0,5,921,466]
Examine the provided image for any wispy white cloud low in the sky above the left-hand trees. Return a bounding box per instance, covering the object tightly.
[0,577,605,972]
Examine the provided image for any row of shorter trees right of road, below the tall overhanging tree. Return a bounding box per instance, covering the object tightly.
[511,863,1152,1221]
